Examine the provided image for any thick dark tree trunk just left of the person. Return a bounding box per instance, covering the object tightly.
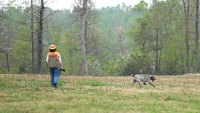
[37,0,44,74]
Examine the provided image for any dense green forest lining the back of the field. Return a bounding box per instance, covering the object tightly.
[0,0,199,76]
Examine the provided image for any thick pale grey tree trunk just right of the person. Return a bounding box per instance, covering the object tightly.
[80,0,88,75]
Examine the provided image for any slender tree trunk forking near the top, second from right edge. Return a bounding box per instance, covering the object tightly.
[182,0,190,73]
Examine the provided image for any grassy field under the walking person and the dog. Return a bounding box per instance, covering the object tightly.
[0,74,200,113]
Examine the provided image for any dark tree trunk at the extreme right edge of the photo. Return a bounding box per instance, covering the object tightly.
[195,0,199,73]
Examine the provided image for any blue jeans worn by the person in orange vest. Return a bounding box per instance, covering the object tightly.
[49,66,60,87]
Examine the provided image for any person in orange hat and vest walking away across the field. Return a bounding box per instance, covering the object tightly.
[46,44,62,88]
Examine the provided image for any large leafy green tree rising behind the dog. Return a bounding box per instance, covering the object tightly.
[126,0,189,74]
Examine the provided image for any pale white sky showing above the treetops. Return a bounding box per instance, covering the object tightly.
[48,0,152,10]
